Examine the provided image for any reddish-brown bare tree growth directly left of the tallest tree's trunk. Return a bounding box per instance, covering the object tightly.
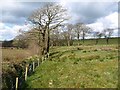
[13,29,40,55]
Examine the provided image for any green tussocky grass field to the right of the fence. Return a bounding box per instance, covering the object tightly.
[26,45,118,88]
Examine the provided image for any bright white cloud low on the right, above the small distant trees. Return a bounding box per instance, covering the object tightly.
[87,12,118,36]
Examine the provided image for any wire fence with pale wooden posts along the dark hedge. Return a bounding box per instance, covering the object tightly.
[3,53,49,90]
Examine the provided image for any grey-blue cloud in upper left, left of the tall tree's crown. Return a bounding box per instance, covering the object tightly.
[0,2,43,25]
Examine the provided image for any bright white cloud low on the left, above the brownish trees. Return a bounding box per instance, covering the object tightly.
[0,23,31,40]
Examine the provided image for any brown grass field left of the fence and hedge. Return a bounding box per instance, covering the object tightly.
[2,48,32,63]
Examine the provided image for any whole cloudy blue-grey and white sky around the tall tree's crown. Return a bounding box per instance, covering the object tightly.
[0,0,118,40]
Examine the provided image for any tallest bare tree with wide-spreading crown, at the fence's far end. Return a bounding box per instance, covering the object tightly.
[29,3,68,55]
